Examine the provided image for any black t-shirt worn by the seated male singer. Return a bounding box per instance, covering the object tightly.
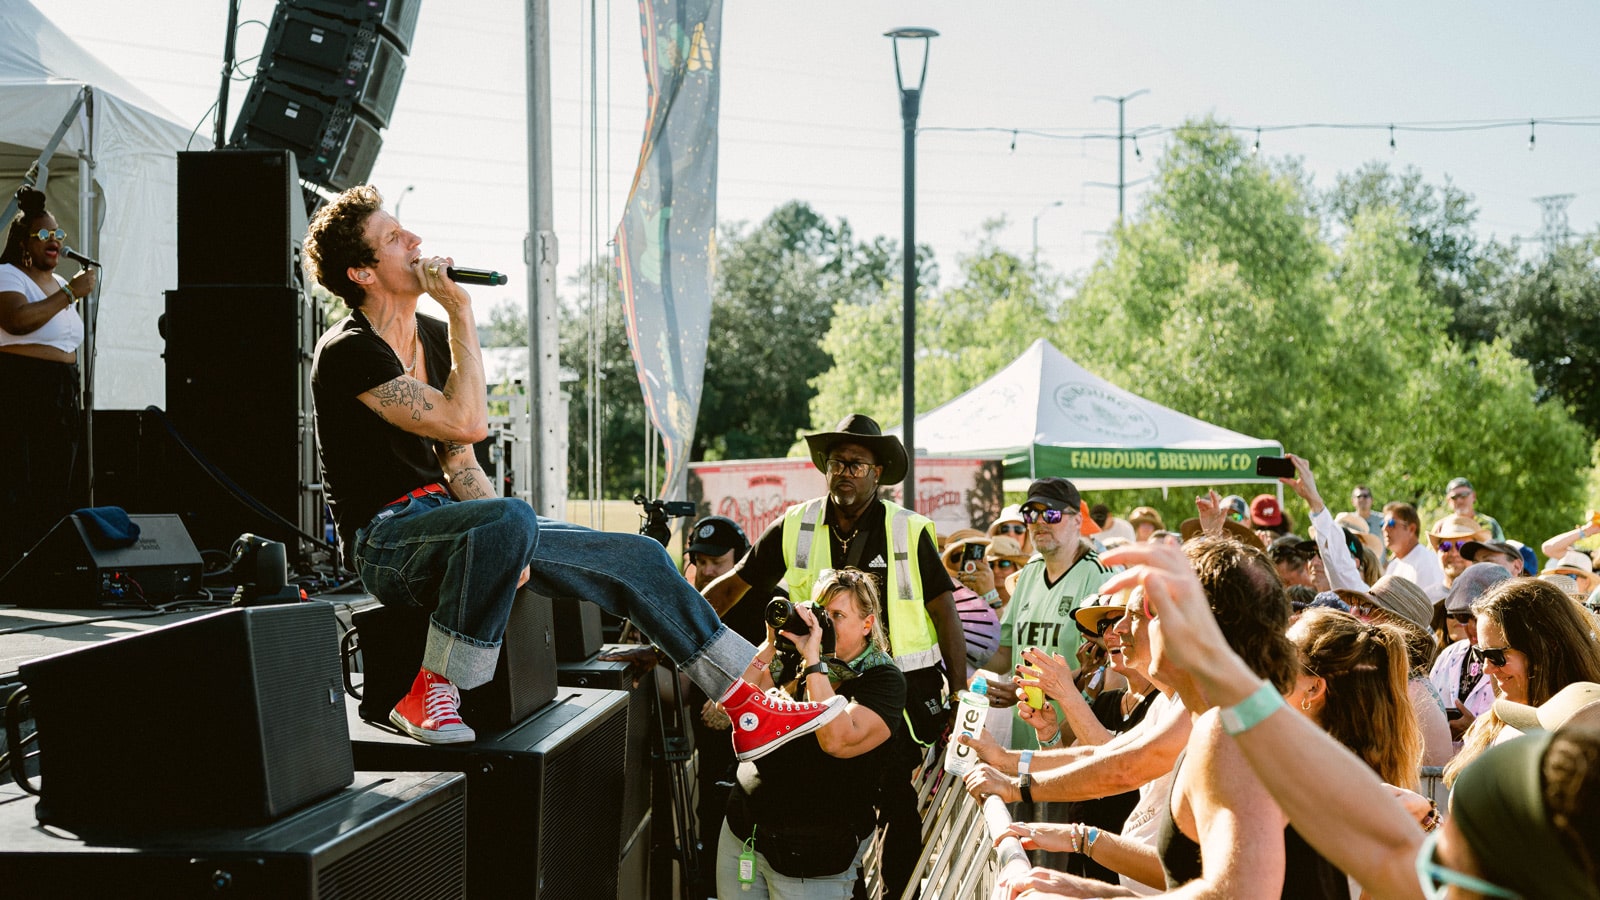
[310,311,450,565]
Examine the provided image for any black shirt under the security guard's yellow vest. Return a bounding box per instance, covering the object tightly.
[730,500,954,641]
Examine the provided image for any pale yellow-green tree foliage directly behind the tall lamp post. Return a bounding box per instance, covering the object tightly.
[811,223,1061,428]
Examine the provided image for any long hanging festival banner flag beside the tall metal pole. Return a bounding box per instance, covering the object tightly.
[616,0,722,500]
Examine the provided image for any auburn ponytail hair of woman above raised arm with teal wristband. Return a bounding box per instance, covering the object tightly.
[1290,609,1422,790]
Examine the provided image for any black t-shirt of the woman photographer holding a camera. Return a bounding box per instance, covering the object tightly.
[728,666,906,839]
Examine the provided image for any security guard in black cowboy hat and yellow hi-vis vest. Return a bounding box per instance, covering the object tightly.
[704,415,966,897]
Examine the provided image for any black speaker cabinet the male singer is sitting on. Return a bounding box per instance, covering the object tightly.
[352,588,557,732]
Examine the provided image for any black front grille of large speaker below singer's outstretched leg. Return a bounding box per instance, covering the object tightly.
[539,708,627,900]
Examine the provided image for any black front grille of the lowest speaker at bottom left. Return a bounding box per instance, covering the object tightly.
[317,781,467,900]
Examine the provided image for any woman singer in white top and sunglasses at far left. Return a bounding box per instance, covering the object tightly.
[0,187,94,563]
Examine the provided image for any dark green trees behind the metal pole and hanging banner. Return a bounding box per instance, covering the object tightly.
[550,203,902,498]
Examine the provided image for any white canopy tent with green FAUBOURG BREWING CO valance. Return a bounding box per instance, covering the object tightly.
[893,338,1283,490]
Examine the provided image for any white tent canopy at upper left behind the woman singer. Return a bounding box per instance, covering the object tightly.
[0,0,190,408]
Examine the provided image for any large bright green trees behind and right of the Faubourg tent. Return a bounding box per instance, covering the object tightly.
[1036,122,1592,543]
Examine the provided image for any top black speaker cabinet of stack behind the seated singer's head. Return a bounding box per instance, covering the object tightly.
[178,149,306,286]
